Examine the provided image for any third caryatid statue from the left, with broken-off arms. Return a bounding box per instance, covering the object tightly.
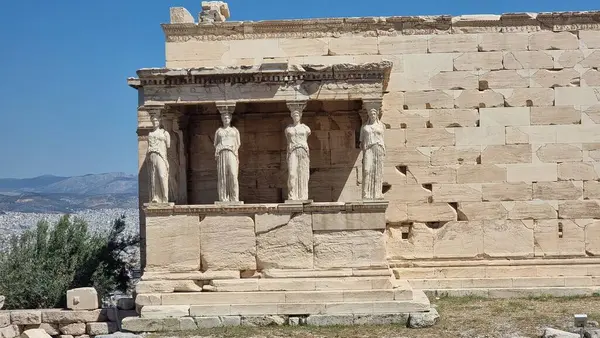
[285,101,311,201]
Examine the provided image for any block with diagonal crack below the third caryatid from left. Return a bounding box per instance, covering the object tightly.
[256,214,314,269]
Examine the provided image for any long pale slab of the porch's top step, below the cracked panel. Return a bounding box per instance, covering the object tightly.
[209,276,394,292]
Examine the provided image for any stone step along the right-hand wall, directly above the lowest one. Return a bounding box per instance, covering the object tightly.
[408,276,600,290]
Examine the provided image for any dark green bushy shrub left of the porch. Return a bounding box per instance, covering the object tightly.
[0,215,139,309]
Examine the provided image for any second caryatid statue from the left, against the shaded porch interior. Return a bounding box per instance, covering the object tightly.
[215,104,241,202]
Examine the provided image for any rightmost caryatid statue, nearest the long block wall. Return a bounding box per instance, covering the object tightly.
[360,101,385,200]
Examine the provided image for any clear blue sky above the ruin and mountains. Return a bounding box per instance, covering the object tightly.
[0,0,600,178]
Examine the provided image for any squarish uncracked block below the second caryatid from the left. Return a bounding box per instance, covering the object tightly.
[200,216,256,270]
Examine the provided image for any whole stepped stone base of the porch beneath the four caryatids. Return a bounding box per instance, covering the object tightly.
[131,201,429,326]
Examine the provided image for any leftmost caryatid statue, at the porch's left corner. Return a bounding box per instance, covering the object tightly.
[146,109,171,203]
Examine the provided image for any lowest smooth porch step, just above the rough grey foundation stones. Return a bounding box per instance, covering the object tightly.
[141,291,430,318]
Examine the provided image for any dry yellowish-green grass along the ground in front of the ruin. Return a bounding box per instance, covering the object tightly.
[153,296,600,338]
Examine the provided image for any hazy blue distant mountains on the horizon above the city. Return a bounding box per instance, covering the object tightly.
[0,173,138,213]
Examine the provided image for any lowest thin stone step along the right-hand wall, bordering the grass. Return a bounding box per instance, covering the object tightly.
[422,287,600,298]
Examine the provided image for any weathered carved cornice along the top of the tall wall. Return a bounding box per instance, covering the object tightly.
[162,11,600,42]
